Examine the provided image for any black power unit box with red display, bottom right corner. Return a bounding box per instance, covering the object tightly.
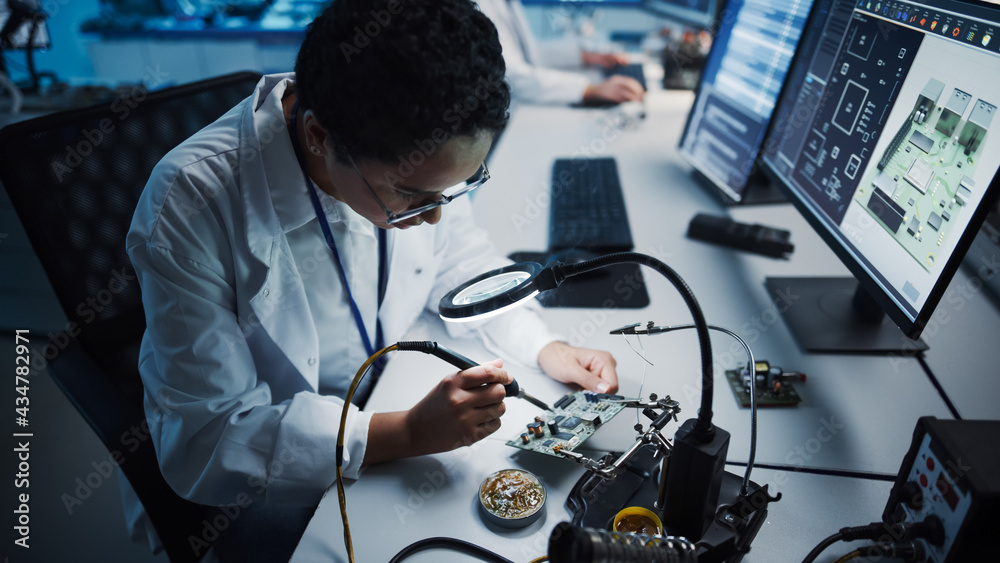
[882,416,1000,563]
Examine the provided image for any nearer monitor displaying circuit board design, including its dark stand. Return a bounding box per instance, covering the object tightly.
[762,0,1000,352]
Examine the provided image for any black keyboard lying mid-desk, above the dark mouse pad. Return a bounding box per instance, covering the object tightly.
[549,154,634,253]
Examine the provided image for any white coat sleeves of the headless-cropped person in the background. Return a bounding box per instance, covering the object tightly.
[477,0,591,104]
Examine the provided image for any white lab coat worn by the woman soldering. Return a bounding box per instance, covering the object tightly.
[126,74,555,548]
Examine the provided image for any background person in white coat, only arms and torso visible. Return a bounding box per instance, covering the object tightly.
[477,0,645,105]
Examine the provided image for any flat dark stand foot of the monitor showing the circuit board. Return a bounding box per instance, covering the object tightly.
[764,277,928,355]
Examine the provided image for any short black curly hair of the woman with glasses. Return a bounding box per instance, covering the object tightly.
[295,0,510,162]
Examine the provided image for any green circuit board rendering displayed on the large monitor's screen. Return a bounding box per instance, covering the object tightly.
[854,79,997,272]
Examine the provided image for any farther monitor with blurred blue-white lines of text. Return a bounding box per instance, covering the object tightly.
[680,0,813,203]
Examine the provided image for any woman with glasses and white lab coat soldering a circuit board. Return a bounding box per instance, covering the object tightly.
[127,0,617,558]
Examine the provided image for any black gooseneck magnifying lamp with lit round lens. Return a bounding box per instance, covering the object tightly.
[438,252,729,538]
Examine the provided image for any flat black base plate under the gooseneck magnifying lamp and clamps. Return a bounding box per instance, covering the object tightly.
[566,446,781,563]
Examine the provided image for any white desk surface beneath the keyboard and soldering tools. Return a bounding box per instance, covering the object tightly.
[293,91,1000,562]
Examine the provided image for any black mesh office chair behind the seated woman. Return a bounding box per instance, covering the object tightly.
[0,72,260,561]
